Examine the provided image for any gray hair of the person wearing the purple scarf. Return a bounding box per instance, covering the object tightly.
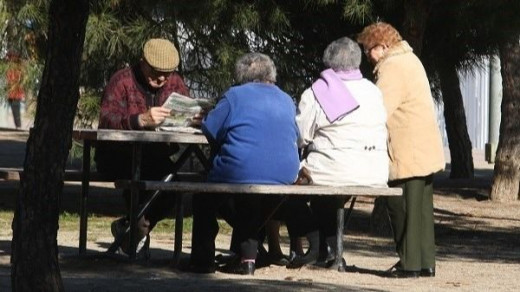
[323,37,361,71]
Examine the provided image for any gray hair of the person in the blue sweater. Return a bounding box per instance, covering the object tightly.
[235,53,276,84]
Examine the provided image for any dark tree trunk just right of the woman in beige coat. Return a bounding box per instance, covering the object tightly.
[437,63,474,178]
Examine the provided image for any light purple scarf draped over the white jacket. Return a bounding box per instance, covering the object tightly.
[311,69,363,123]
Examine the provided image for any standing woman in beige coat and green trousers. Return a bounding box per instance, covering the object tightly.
[358,22,445,278]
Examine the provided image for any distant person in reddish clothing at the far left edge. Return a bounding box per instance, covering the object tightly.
[6,51,25,130]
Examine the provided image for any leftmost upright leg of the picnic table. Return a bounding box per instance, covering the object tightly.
[79,140,91,255]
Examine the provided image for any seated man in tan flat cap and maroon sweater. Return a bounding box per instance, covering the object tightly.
[95,38,189,259]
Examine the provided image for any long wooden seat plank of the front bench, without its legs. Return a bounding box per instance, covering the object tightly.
[115,180,402,196]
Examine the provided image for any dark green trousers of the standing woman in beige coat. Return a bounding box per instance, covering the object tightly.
[386,175,435,271]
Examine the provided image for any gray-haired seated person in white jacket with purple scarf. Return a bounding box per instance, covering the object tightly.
[296,37,389,267]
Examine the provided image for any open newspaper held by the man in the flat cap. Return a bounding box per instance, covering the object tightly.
[161,92,215,130]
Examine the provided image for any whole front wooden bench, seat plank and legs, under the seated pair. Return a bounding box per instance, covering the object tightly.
[115,180,402,271]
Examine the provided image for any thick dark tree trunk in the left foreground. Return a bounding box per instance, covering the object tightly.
[11,0,88,291]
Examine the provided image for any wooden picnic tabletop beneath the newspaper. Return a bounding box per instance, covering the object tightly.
[72,129,208,144]
